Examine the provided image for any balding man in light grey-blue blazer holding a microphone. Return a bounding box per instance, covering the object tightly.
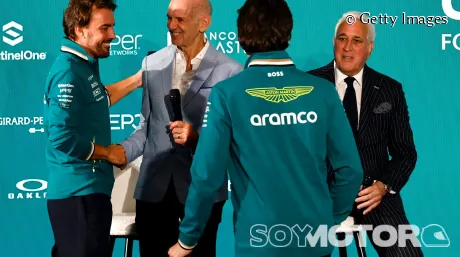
[116,0,243,257]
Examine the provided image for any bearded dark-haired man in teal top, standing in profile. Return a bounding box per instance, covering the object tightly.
[44,0,142,257]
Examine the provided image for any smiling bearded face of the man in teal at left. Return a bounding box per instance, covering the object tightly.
[76,7,116,58]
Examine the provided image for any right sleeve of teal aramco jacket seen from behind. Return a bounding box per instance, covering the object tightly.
[327,87,363,224]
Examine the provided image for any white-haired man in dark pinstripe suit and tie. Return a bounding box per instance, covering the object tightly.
[308,12,423,257]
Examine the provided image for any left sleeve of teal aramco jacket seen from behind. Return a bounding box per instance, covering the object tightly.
[179,86,231,248]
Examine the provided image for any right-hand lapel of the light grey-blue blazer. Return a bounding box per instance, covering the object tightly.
[182,45,218,109]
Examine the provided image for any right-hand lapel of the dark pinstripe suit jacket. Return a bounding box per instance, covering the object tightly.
[358,65,380,135]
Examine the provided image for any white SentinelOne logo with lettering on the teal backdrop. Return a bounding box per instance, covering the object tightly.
[0,21,46,61]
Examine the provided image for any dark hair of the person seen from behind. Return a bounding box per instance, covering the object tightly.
[237,0,294,54]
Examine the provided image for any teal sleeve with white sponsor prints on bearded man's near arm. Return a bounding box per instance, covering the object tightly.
[47,71,94,160]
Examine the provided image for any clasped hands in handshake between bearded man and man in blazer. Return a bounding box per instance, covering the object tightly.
[91,144,128,169]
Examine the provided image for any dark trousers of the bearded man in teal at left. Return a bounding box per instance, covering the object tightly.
[47,194,112,257]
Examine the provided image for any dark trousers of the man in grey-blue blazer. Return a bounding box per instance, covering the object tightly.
[136,178,225,257]
